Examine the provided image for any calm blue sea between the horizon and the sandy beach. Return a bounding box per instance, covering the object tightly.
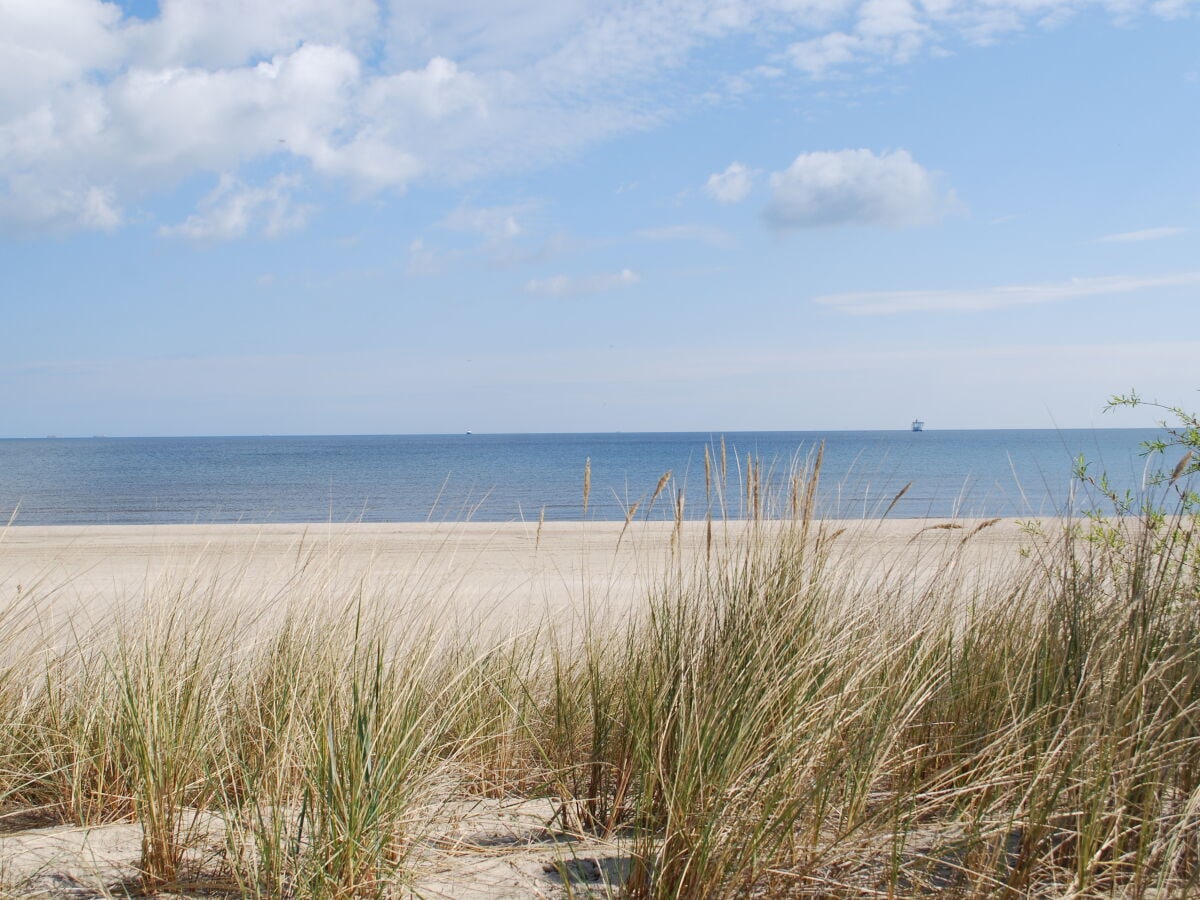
[0,428,1176,524]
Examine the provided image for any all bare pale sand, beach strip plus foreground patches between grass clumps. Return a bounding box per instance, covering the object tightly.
[0,520,1031,900]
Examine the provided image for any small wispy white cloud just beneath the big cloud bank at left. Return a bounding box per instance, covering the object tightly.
[158,175,311,241]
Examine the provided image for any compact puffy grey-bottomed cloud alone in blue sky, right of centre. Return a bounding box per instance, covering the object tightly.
[764,150,954,230]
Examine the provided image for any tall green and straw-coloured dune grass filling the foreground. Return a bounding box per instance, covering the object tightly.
[0,460,1200,899]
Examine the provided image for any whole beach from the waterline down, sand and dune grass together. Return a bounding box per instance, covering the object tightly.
[0,517,1200,900]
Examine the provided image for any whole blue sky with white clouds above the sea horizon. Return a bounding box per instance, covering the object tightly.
[0,0,1200,437]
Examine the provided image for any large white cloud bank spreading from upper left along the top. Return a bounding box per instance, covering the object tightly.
[0,0,1194,236]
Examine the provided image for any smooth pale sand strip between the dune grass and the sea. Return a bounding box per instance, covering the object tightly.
[0,518,1030,626]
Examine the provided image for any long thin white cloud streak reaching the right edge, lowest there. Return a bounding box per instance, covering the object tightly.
[814,272,1200,316]
